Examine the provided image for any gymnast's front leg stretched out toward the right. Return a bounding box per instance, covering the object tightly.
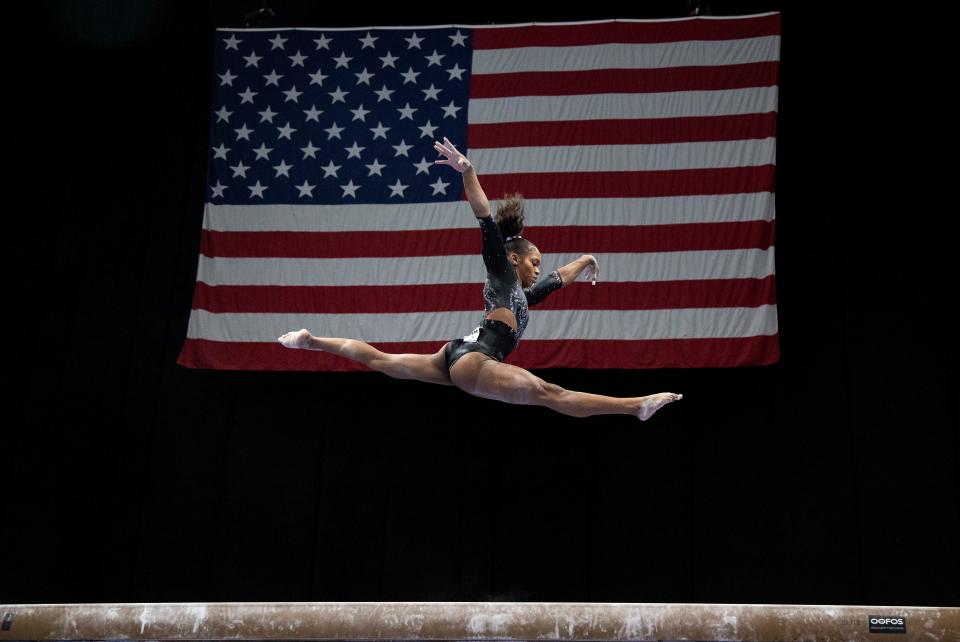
[450,352,683,421]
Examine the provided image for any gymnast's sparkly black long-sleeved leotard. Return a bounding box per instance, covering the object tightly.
[444,216,563,369]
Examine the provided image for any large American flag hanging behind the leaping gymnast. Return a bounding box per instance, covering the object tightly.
[178,13,780,370]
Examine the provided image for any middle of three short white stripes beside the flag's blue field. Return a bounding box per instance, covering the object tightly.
[468,86,777,125]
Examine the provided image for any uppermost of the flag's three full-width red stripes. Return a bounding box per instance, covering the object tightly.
[200,221,772,259]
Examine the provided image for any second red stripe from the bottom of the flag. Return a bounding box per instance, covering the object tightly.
[193,276,777,314]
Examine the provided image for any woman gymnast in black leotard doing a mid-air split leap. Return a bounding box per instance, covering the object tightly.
[278,138,682,420]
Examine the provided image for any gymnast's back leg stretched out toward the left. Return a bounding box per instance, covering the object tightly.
[277,329,453,386]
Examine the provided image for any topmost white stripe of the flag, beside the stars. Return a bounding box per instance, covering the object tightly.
[470,36,780,76]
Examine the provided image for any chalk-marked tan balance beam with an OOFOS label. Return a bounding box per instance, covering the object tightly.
[0,602,960,642]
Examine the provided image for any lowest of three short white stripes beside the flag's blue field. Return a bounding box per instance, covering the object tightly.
[470,138,777,176]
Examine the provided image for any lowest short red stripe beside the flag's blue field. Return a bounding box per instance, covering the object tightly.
[478,165,776,198]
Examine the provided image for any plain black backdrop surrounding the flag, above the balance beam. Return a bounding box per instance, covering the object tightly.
[0,0,960,605]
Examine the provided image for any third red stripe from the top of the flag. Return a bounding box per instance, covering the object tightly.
[467,112,777,149]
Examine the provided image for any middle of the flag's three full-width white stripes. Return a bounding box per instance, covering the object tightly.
[197,248,774,287]
